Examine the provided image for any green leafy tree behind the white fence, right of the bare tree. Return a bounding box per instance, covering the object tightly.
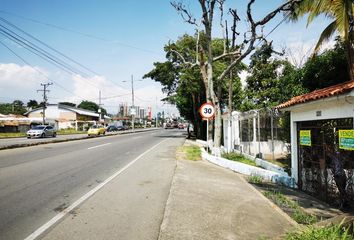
[242,43,307,111]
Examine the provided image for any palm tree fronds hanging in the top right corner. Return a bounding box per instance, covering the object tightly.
[289,0,354,80]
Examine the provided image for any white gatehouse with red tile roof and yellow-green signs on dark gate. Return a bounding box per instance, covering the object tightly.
[277,81,354,202]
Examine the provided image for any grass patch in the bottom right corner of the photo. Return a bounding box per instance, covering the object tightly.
[285,225,354,240]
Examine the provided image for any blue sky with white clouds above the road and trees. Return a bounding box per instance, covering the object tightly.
[0,0,327,113]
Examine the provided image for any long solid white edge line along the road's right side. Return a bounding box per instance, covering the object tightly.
[24,138,168,240]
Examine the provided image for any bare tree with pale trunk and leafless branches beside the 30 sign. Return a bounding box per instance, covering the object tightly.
[172,0,301,151]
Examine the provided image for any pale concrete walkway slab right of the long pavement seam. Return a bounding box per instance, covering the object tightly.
[159,157,294,240]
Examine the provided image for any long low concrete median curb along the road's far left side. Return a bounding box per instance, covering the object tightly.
[0,128,159,151]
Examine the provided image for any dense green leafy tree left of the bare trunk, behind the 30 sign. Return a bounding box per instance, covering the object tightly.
[144,34,205,139]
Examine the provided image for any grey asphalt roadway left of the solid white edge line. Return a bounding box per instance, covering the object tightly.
[0,130,183,240]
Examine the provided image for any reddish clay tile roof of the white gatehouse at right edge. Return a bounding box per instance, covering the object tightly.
[276,80,354,109]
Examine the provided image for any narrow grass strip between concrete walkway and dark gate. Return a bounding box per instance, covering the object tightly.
[263,191,318,225]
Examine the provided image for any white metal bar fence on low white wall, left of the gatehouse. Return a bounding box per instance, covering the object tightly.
[224,109,290,160]
